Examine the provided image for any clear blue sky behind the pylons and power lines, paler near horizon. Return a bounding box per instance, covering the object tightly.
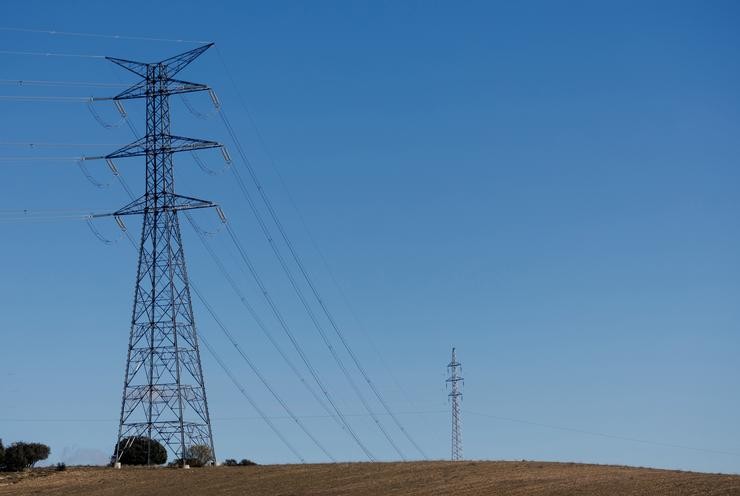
[0,1,740,473]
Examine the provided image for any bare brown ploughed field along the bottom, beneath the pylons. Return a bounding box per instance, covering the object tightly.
[0,462,740,496]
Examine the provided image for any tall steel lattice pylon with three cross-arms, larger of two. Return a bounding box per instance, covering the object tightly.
[99,44,221,465]
